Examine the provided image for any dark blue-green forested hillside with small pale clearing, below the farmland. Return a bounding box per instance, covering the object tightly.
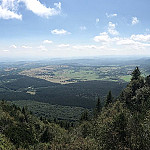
[0,75,126,108]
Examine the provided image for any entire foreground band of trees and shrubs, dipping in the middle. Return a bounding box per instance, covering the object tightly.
[0,67,150,150]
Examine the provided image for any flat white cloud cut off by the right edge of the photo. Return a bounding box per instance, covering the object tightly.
[130,34,150,42]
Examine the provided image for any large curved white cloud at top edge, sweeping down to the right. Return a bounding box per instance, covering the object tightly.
[19,0,61,18]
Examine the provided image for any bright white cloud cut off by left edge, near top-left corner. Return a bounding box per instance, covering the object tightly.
[0,6,22,20]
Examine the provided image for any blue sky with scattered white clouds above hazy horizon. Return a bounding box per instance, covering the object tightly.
[0,0,150,60]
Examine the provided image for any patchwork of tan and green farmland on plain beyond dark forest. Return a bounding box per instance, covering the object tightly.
[20,65,138,84]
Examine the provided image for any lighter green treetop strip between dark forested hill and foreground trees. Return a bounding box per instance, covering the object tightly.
[12,100,86,121]
